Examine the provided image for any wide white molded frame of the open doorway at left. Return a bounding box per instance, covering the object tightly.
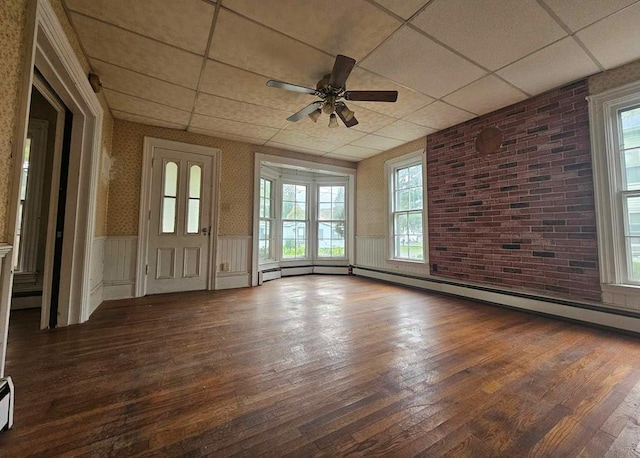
[0,0,103,375]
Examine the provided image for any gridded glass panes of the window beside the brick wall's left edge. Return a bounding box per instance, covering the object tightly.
[391,160,425,262]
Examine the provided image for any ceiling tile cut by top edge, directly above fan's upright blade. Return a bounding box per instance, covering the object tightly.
[224,0,401,60]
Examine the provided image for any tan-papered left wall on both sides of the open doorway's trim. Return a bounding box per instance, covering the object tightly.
[0,0,113,241]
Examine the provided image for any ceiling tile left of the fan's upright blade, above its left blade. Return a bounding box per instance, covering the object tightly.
[209,9,334,87]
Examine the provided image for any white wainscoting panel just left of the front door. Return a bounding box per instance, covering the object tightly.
[102,236,138,300]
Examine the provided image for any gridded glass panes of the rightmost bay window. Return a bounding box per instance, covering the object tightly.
[317,185,346,258]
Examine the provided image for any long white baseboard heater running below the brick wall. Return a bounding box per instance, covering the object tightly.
[353,267,640,333]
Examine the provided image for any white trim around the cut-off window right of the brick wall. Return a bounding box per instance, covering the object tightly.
[588,81,640,309]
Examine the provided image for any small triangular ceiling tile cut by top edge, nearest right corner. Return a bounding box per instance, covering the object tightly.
[544,0,637,32]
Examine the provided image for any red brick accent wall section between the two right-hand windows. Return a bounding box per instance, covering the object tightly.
[427,80,601,301]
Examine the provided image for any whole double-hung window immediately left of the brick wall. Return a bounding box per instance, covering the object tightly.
[385,152,427,263]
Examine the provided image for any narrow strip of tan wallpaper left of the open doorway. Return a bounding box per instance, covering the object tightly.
[0,0,27,242]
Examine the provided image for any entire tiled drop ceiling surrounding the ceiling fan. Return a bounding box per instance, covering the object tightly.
[64,0,640,161]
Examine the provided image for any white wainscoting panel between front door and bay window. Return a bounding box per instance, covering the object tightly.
[215,236,252,289]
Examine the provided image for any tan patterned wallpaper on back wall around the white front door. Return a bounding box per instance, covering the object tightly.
[107,119,355,236]
